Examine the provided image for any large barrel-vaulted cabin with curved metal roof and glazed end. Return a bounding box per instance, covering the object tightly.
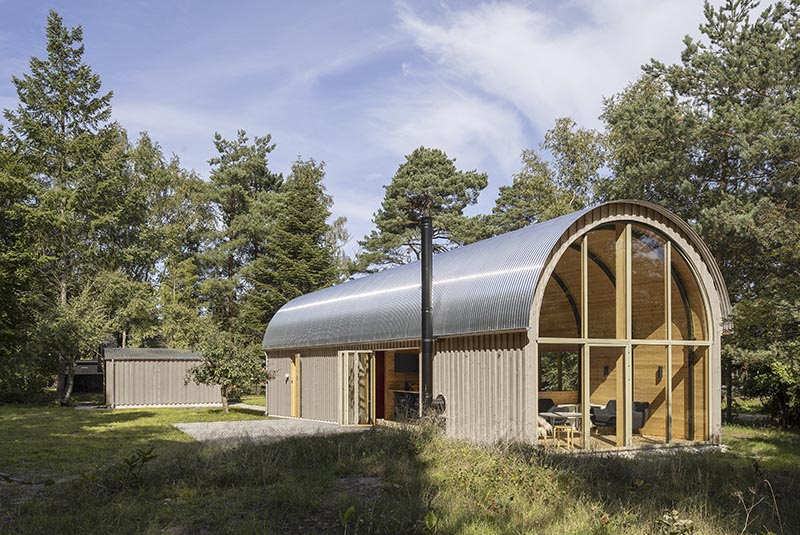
[263,200,730,449]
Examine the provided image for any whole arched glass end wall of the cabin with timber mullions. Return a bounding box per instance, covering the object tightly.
[537,222,710,449]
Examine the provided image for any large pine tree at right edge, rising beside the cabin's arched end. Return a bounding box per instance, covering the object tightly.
[600,0,800,425]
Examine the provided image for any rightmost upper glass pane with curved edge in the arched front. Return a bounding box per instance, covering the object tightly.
[672,249,708,340]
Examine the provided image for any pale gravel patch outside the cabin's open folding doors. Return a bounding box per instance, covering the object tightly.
[175,418,369,442]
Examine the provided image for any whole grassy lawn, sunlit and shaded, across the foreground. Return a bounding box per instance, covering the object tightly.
[0,407,800,535]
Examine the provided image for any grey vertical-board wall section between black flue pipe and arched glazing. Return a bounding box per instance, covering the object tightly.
[433,332,527,442]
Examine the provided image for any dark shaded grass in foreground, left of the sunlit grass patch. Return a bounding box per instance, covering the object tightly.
[0,431,438,533]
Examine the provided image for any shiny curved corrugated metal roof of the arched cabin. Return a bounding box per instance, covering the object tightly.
[263,208,591,349]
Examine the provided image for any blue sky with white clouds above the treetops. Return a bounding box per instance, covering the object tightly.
[0,0,703,252]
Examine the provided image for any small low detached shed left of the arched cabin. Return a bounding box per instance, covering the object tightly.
[103,348,222,409]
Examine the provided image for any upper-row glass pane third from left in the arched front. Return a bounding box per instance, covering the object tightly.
[631,226,667,340]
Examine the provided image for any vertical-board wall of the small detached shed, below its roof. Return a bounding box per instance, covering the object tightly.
[106,358,221,408]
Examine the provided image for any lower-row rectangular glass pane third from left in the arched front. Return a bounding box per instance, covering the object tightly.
[631,346,668,446]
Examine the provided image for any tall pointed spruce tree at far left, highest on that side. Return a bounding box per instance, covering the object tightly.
[4,11,121,402]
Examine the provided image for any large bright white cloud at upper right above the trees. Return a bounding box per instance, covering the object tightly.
[399,0,702,132]
